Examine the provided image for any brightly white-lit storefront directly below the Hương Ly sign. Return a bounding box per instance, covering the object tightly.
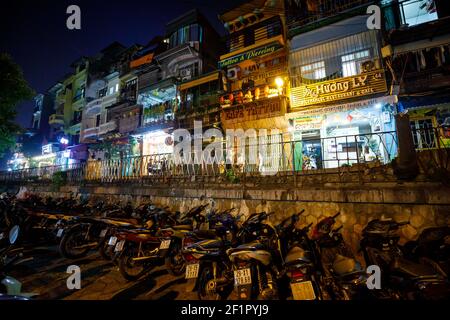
[286,96,397,170]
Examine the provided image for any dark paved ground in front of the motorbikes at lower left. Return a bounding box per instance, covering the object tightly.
[10,247,197,300]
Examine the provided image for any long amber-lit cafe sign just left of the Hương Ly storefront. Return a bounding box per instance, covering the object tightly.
[221,99,283,123]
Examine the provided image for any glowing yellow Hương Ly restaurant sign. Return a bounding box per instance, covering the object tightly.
[291,70,387,108]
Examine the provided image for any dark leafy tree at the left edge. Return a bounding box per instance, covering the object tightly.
[0,53,35,156]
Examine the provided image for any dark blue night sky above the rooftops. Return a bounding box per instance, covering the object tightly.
[0,0,243,127]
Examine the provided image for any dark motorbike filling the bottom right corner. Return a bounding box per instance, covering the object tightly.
[361,219,450,300]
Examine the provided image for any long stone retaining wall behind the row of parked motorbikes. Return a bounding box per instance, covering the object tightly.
[11,183,450,260]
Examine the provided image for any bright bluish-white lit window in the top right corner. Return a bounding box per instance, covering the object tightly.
[399,0,438,26]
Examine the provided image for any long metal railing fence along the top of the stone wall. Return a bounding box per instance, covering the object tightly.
[0,127,450,183]
